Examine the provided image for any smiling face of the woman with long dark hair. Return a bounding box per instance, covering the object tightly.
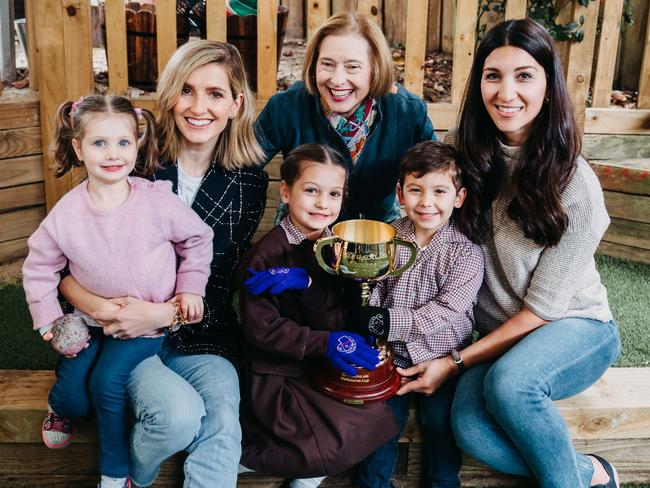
[481,46,546,146]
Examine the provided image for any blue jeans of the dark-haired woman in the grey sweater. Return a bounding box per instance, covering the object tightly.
[452,318,621,488]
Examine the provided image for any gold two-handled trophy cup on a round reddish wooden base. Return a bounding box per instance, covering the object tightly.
[314,219,417,404]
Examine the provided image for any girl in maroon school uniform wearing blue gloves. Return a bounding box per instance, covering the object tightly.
[240,144,397,488]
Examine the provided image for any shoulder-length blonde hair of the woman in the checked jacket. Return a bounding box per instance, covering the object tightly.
[156,40,264,171]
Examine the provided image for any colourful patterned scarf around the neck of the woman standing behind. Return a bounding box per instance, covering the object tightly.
[321,97,377,163]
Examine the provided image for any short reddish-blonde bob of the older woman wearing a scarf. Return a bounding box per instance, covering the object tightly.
[302,12,394,98]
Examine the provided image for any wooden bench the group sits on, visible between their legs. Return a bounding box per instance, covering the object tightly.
[0,368,650,488]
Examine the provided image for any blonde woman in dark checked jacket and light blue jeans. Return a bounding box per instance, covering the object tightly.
[61,41,268,487]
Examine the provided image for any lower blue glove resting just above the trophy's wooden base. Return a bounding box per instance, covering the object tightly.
[327,332,379,376]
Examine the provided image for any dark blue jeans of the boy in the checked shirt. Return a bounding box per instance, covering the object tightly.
[359,378,462,488]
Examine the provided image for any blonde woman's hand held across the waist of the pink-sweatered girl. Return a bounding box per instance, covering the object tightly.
[90,297,175,339]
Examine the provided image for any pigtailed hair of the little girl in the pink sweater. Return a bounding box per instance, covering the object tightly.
[50,95,159,177]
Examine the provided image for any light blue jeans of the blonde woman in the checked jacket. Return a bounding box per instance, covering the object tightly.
[128,342,241,488]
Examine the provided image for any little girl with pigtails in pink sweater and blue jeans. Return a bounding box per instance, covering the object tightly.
[23,96,212,488]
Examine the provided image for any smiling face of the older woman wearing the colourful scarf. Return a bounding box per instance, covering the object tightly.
[316,34,372,117]
